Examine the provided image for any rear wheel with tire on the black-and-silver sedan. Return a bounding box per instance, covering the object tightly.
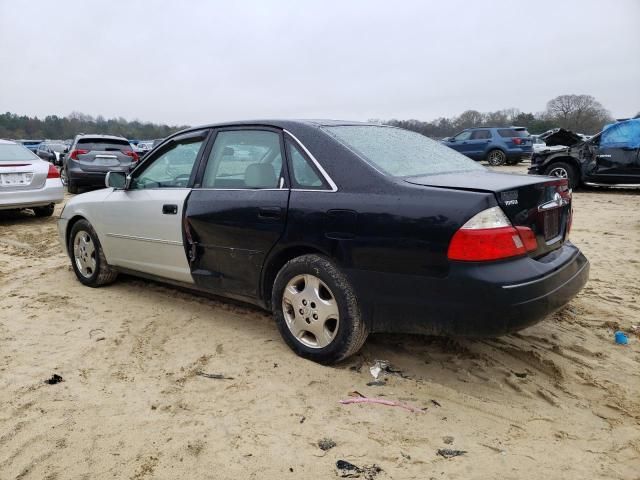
[271,255,369,364]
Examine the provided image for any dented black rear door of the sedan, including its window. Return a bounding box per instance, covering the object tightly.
[185,127,289,298]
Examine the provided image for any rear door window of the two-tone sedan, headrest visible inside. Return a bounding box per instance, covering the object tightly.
[202,130,282,189]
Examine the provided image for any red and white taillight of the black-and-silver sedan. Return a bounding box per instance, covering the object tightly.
[447,207,538,262]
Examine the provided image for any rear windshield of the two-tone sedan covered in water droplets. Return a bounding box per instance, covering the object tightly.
[325,125,484,177]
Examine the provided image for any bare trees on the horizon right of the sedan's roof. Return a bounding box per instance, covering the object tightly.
[375,95,628,138]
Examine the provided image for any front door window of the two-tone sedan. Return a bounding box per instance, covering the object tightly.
[130,140,203,189]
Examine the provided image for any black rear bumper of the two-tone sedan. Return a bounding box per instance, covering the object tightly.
[349,242,589,336]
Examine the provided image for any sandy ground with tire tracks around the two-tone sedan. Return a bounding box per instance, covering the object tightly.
[0,163,640,480]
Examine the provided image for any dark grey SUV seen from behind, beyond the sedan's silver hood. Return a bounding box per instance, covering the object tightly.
[60,135,139,193]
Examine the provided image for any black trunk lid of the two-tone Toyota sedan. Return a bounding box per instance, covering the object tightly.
[405,171,571,257]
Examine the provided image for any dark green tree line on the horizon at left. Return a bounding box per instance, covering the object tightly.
[0,112,186,140]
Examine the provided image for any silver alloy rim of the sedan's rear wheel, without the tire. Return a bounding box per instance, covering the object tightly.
[282,274,340,348]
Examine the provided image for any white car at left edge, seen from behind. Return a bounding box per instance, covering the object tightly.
[0,140,64,217]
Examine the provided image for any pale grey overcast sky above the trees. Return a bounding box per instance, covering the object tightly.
[0,0,640,125]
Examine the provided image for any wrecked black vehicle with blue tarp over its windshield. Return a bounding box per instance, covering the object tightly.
[529,118,640,188]
